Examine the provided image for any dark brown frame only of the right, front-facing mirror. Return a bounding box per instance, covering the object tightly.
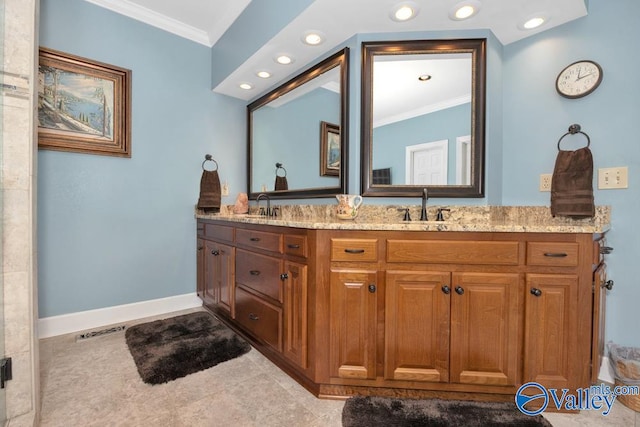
[360,39,486,198]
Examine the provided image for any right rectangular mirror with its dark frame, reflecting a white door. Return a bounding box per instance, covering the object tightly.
[361,39,486,197]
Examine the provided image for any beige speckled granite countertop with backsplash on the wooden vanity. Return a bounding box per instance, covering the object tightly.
[196,205,611,234]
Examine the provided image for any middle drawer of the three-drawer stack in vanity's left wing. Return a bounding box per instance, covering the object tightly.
[236,249,283,302]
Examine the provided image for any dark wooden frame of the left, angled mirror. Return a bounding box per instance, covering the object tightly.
[247,47,349,199]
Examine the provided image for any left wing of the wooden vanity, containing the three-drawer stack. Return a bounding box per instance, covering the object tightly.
[198,221,308,368]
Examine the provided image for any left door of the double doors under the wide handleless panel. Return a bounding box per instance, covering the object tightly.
[384,271,451,382]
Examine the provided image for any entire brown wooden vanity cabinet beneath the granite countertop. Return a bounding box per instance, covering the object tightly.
[198,220,606,400]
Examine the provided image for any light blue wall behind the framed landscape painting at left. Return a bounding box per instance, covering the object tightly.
[38,0,246,317]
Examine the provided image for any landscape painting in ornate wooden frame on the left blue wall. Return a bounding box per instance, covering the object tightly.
[38,48,131,157]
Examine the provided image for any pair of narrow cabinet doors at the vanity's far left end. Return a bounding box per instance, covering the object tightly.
[204,241,235,317]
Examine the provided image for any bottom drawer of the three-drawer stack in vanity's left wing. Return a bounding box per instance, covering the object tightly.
[236,287,282,351]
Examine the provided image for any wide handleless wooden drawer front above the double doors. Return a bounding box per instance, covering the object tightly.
[387,240,518,265]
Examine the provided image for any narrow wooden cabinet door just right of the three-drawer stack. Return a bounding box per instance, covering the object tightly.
[282,261,308,369]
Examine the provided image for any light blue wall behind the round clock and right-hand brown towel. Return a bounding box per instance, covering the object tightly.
[502,0,640,347]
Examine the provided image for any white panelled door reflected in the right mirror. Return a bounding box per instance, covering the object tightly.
[405,139,449,185]
